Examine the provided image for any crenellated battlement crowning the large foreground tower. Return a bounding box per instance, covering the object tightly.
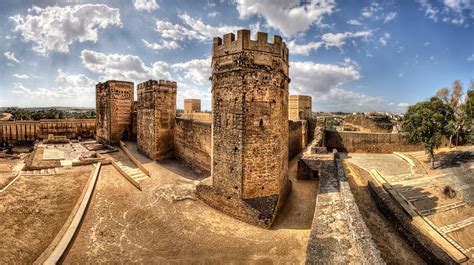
[212,29,288,64]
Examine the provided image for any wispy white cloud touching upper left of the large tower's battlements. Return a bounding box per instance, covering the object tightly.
[155,13,241,42]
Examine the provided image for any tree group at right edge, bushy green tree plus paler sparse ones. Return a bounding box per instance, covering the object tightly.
[401,80,474,168]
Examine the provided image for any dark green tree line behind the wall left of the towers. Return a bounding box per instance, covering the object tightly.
[3,108,95,121]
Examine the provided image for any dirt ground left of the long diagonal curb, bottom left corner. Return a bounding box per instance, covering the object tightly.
[0,166,94,264]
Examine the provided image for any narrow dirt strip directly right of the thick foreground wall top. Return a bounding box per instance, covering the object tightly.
[344,162,425,264]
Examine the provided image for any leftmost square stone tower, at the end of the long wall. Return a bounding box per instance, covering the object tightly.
[96,80,134,144]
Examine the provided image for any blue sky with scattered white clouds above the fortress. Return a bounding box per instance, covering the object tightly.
[0,0,474,112]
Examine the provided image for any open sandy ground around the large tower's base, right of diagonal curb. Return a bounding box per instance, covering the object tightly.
[65,146,317,264]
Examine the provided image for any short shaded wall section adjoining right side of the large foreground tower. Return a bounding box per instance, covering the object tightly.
[288,120,308,160]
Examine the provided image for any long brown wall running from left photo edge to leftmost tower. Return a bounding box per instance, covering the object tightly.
[0,119,95,144]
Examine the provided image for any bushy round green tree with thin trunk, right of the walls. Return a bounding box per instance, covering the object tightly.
[402,97,454,168]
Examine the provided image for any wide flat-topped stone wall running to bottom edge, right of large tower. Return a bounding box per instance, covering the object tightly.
[306,154,385,264]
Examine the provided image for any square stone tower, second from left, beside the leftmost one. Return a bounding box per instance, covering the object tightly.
[137,80,177,160]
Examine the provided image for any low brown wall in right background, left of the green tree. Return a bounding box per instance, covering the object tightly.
[325,130,423,153]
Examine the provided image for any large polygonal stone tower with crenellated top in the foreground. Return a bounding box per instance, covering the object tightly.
[197,30,291,227]
